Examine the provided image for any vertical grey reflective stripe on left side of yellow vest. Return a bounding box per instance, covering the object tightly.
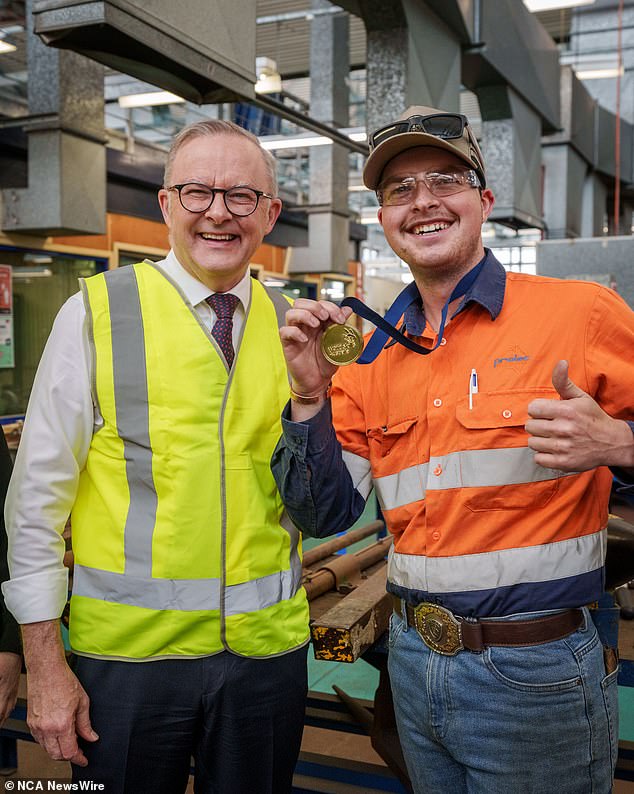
[106,267,158,577]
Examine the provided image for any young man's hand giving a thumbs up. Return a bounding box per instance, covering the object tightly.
[525,361,634,471]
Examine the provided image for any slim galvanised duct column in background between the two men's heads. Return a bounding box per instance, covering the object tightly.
[289,0,350,274]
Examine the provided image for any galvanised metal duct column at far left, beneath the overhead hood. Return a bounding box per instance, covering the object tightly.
[2,0,106,236]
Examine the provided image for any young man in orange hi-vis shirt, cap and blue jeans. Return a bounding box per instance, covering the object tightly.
[273,107,634,794]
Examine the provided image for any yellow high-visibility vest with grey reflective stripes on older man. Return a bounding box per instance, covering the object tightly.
[70,262,308,659]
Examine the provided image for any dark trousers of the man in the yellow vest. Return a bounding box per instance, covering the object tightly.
[73,647,307,794]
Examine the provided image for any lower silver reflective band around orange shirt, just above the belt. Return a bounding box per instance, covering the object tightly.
[387,529,607,593]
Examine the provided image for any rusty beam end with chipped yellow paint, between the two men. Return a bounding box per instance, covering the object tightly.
[310,564,392,662]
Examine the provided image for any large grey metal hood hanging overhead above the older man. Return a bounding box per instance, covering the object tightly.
[33,0,256,104]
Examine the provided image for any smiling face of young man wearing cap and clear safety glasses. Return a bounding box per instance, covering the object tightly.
[378,146,494,282]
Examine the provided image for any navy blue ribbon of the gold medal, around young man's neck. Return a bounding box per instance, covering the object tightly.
[340,257,486,364]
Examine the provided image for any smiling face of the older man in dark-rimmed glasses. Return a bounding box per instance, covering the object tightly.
[159,133,282,292]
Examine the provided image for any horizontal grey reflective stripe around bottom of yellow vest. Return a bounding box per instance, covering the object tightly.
[73,565,299,615]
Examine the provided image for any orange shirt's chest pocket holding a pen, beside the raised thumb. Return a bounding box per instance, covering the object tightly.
[456,388,562,512]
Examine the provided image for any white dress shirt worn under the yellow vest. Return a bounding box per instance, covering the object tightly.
[2,251,251,623]
